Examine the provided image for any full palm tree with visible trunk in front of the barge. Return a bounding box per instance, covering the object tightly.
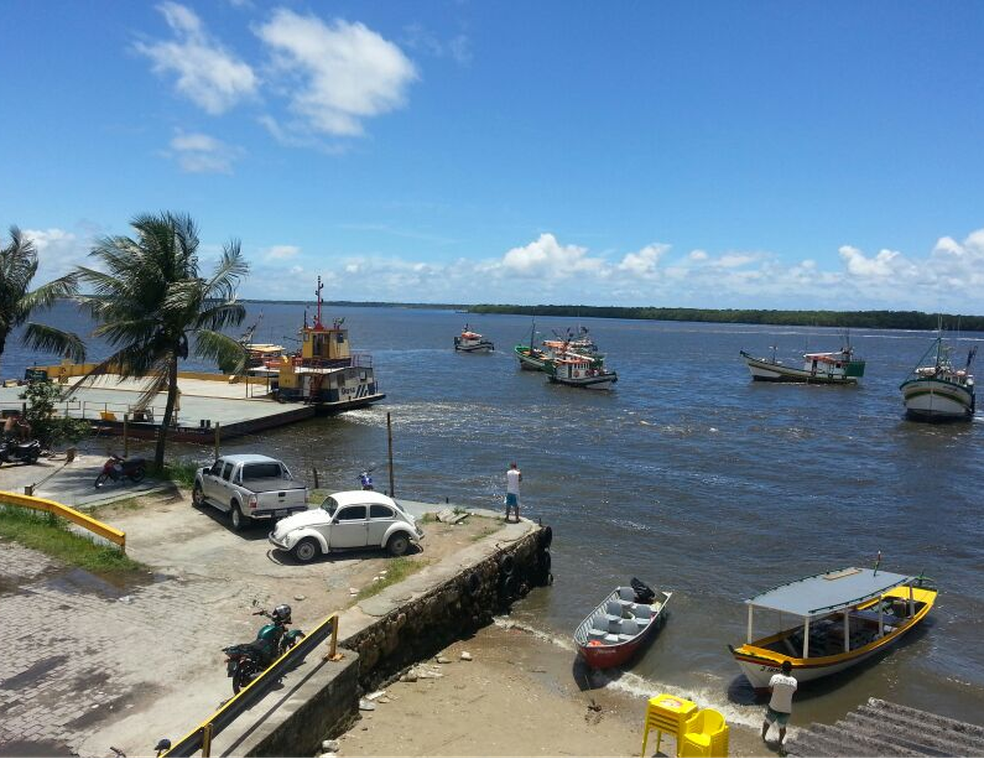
[78,213,249,469]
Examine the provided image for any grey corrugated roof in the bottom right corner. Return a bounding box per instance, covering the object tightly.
[786,698,984,757]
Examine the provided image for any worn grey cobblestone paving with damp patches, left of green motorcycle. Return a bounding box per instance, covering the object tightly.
[0,542,251,755]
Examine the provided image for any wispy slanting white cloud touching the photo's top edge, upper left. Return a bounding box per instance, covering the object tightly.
[134,2,259,115]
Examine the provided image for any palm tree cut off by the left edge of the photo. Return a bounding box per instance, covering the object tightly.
[0,227,85,372]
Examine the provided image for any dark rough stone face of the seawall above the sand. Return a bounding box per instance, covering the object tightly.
[342,527,552,692]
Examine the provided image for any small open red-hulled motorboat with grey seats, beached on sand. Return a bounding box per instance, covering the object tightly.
[574,578,673,669]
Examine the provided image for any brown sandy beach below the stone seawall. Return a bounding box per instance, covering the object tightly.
[339,620,775,757]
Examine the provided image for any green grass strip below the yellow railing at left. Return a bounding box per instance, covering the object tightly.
[0,504,146,574]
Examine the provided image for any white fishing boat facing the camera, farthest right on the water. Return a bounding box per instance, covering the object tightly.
[899,334,977,422]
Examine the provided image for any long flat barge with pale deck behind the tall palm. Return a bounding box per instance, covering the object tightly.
[0,375,316,443]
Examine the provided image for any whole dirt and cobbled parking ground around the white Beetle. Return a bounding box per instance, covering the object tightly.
[0,491,508,756]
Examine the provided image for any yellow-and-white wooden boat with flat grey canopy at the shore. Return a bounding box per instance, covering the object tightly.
[729,567,937,693]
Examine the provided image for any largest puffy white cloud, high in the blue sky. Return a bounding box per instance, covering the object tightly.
[255,8,418,137]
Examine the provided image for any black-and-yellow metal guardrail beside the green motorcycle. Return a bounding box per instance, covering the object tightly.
[160,612,338,759]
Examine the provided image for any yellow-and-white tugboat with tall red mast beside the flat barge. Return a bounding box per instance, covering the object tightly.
[258,277,386,412]
